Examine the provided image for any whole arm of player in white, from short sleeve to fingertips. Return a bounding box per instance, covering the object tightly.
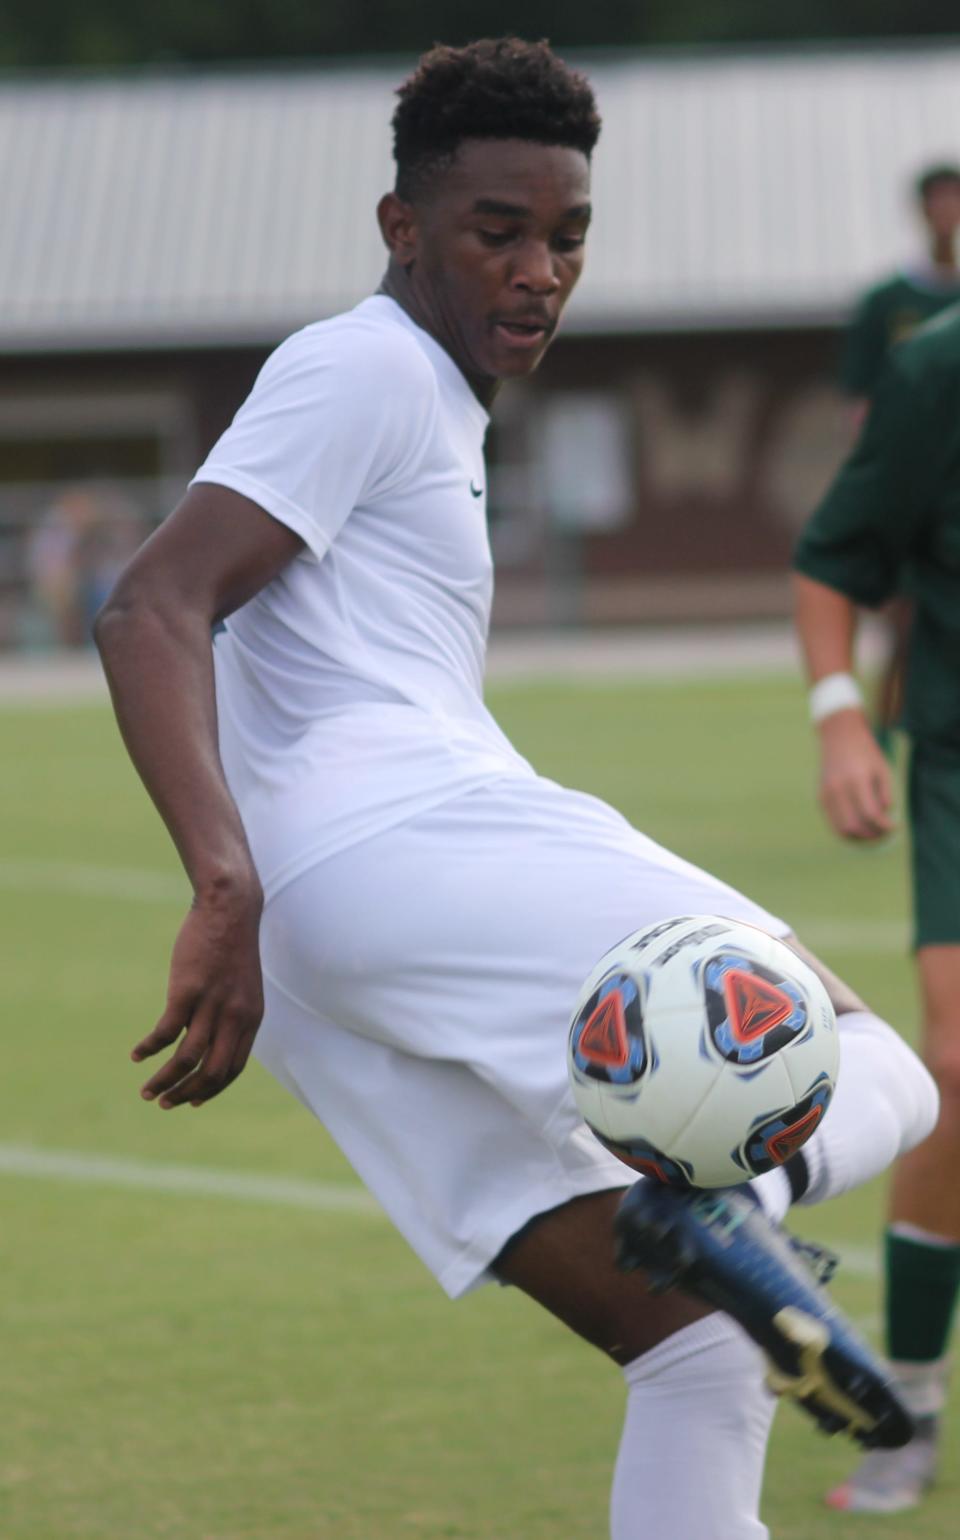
[96,316,438,1107]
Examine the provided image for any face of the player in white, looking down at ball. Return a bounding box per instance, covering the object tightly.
[388,139,590,380]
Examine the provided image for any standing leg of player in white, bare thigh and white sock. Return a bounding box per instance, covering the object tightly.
[493,1192,774,1540]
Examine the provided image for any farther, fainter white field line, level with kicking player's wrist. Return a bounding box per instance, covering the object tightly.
[0,859,909,955]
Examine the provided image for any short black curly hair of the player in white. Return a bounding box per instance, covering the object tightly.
[393,37,599,202]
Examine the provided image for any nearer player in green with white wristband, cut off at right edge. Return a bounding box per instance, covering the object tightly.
[795,305,960,1512]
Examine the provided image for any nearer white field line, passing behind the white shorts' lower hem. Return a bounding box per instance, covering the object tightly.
[0,1144,880,1278]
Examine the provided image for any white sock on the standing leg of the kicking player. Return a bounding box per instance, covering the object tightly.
[610,1315,777,1540]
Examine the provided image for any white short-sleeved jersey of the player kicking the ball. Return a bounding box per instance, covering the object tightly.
[194,296,533,896]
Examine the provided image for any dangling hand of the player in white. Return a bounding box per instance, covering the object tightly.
[131,895,263,1109]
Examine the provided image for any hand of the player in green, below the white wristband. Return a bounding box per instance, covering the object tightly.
[820,710,897,841]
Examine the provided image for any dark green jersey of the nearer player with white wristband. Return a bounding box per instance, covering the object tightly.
[795,305,960,745]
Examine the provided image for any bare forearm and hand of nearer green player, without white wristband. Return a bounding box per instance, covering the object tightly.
[794,573,895,839]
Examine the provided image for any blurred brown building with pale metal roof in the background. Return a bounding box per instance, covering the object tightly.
[0,40,960,647]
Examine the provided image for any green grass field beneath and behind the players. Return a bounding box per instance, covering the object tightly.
[0,681,960,1540]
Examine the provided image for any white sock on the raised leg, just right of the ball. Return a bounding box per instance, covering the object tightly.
[800,1010,938,1203]
